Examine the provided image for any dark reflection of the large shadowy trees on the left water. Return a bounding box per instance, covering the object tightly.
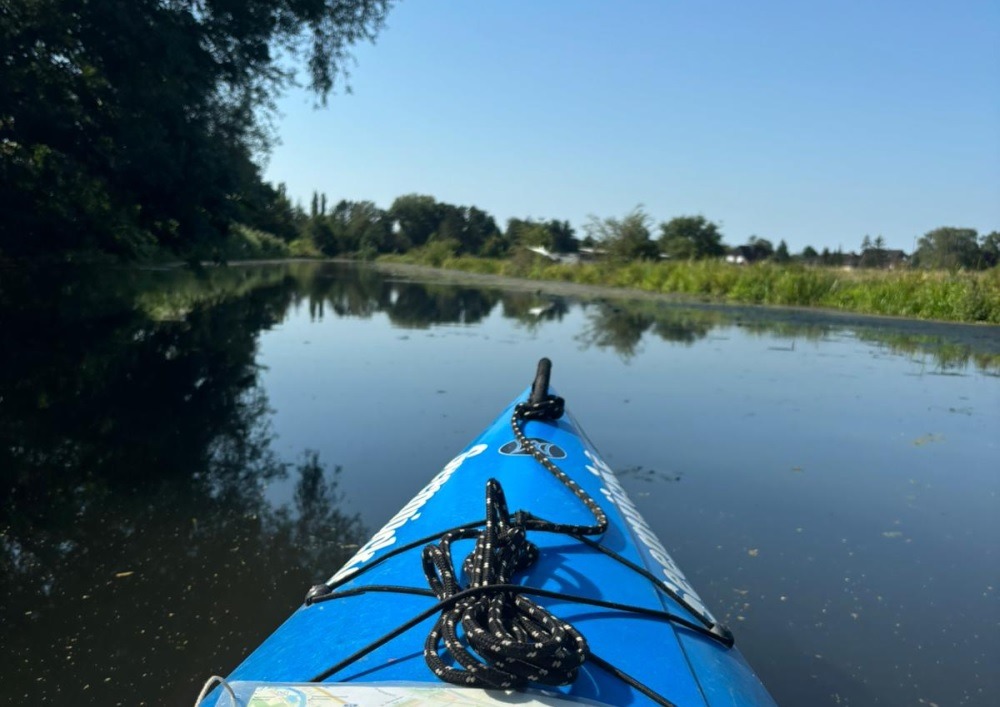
[0,271,364,704]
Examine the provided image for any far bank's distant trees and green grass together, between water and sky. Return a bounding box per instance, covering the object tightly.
[158,199,1000,325]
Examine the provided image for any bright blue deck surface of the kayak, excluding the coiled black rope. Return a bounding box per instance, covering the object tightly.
[203,362,773,705]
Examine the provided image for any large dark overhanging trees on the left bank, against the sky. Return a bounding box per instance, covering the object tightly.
[0,0,389,256]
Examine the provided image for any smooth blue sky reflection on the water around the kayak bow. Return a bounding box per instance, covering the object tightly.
[259,284,1000,704]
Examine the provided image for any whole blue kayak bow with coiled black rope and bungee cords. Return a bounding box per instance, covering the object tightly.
[199,359,774,707]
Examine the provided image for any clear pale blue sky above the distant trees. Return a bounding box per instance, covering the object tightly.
[266,0,1000,251]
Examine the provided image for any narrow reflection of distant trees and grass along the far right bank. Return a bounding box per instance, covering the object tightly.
[289,263,1000,373]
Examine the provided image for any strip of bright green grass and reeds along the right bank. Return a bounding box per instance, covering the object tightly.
[385,251,1000,324]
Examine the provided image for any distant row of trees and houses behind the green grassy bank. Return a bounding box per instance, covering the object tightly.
[278,198,1000,269]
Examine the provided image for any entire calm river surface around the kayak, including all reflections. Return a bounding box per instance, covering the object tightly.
[0,264,1000,707]
